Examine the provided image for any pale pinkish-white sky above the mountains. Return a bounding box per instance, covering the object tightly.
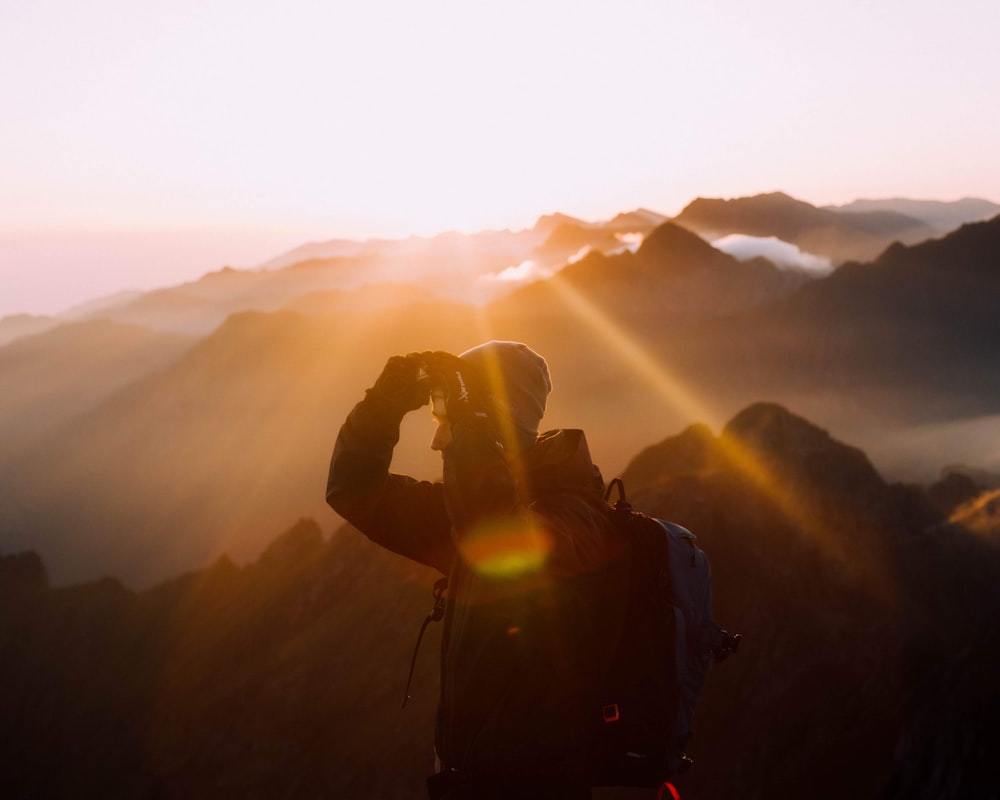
[0,0,1000,316]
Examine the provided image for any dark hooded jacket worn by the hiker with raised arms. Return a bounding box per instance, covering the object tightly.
[327,395,616,780]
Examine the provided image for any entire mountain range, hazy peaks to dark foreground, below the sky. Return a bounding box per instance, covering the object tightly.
[0,194,1000,800]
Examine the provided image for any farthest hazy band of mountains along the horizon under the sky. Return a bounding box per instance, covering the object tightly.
[0,193,1000,344]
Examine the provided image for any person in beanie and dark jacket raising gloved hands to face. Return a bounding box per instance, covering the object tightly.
[327,341,617,800]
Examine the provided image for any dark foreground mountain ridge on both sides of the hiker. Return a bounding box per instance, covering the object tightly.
[0,410,1000,800]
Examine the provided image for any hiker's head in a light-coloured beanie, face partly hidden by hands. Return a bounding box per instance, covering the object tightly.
[431,341,552,451]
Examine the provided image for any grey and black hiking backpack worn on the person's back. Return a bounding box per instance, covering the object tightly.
[592,478,742,787]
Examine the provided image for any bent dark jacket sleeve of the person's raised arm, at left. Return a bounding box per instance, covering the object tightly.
[326,394,455,574]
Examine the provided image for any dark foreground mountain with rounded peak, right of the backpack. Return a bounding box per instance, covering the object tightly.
[624,404,1000,800]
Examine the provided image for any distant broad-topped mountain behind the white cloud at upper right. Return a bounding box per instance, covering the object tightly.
[674,192,941,263]
